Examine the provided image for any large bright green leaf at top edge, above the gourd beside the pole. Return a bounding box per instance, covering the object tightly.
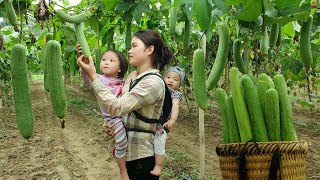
[193,0,212,31]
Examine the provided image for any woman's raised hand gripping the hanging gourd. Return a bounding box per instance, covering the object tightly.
[77,54,97,81]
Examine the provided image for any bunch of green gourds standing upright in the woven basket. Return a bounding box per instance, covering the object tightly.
[215,67,297,143]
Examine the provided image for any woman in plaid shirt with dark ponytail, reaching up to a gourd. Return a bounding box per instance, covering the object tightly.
[77,30,173,180]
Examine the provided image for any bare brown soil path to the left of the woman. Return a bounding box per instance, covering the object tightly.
[0,82,118,180]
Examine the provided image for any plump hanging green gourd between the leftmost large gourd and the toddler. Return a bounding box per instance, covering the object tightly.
[46,40,67,119]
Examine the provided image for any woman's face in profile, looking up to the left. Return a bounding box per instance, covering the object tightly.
[129,36,150,66]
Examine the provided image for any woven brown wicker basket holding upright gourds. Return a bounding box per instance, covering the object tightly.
[216,141,308,180]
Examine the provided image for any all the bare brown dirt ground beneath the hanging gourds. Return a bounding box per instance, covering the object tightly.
[0,81,320,180]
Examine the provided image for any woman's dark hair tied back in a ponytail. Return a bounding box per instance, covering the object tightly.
[133,29,173,71]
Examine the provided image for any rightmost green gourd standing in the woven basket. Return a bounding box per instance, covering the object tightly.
[273,74,298,141]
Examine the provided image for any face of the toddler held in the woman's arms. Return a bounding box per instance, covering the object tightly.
[100,51,121,77]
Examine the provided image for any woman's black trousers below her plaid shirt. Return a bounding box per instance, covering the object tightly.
[127,156,159,180]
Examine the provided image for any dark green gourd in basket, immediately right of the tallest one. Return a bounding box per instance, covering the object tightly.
[241,76,269,142]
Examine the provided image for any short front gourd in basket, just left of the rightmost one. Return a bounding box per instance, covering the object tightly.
[265,88,281,141]
